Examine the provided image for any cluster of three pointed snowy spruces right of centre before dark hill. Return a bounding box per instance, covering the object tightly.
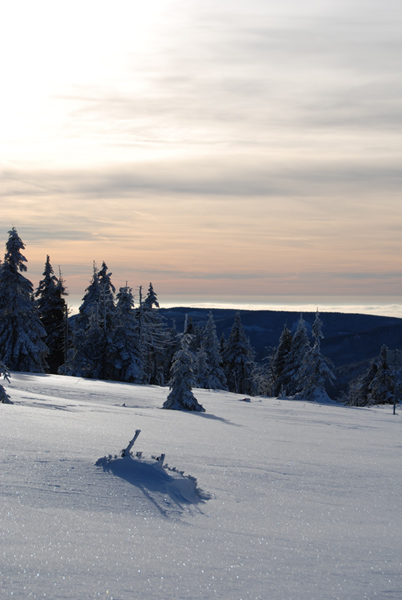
[270,310,335,400]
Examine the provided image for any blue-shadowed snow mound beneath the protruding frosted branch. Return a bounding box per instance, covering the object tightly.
[95,455,210,516]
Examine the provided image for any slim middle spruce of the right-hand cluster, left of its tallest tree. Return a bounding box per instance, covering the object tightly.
[285,315,310,396]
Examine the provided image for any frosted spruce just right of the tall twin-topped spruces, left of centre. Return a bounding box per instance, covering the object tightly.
[113,284,144,383]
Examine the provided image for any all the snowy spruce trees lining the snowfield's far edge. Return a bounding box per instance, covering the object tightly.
[0,228,398,411]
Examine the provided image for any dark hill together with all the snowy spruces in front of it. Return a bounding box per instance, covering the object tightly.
[0,228,402,411]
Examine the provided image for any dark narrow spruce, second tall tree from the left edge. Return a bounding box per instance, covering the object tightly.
[35,256,67,373]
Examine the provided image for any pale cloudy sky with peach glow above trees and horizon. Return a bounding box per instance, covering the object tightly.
[0,0,402,310]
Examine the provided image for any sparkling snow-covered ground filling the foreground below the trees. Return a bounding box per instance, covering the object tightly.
[0,373,402,600]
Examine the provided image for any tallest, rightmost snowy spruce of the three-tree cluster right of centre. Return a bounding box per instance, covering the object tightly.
[295,310,335,401]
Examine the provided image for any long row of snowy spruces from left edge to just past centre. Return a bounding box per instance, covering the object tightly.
[0,228,252,408]
